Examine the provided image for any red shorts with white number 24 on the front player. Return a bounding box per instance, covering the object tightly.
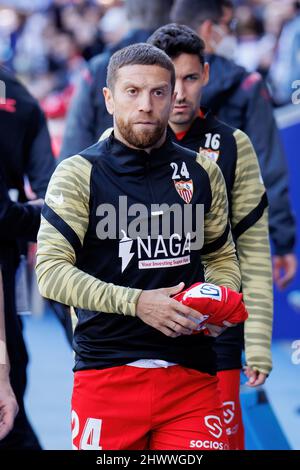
[72,365,228,450]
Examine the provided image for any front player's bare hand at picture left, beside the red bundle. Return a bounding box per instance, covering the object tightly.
[136,282,209,338]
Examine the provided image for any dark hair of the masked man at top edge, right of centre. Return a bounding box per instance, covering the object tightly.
[170,0,223,30]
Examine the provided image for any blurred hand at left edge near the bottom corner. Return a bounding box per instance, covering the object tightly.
[0,376,19,440]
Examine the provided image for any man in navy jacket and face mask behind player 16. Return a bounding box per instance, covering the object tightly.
[171,0,297,289]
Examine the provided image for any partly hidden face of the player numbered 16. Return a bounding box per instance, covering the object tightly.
[169,53,209,126]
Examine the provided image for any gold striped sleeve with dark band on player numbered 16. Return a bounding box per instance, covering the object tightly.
[232,130,273,374]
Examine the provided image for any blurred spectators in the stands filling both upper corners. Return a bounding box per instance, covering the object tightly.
[0,0,300,111]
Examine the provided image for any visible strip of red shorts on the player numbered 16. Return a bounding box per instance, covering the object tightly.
[218,369,245,450]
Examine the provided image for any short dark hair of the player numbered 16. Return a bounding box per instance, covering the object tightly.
[147,23,205,65]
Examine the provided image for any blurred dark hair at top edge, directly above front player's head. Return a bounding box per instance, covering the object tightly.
[125,0,174,31]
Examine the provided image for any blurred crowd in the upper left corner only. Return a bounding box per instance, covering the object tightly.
[0,0,127,117]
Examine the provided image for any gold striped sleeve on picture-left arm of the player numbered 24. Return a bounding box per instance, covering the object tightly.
[36,155,141,316]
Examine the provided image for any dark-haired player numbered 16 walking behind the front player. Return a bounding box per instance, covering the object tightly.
[148,24,273,450]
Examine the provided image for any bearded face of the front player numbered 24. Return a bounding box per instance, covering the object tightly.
[103,65,174,149]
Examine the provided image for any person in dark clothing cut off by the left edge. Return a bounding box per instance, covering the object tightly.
[0,68,55,449]
